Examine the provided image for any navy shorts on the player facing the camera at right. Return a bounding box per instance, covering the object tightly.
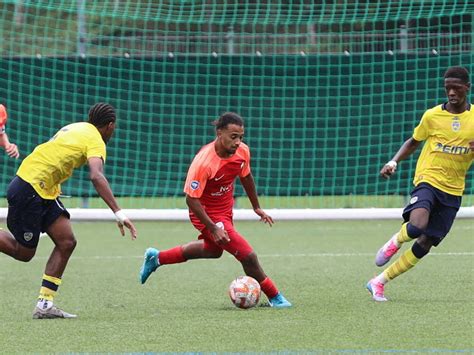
[403,183,461,246]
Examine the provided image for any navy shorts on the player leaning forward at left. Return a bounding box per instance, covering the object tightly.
[7,176,70,249]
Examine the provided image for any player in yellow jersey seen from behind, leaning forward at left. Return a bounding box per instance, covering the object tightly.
[0,103,137,319]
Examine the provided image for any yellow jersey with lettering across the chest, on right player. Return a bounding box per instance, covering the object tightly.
[413,104,474,196]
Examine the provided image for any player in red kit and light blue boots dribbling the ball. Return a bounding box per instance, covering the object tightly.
[140,112,291,308]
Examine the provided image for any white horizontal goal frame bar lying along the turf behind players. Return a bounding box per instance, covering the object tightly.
[0,206,474,221]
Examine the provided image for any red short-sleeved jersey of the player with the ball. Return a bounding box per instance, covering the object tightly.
[184,141,250,223]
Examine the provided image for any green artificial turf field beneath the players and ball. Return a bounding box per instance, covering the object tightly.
[0,219,474,354]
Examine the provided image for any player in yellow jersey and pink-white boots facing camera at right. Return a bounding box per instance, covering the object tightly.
[367,67,474,302]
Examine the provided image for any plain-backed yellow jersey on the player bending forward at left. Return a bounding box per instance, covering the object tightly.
[17,122,106,200]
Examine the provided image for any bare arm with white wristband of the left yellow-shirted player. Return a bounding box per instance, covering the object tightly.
[88,157,137,240]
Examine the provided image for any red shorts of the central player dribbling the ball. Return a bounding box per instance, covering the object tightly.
[193,218,253,261]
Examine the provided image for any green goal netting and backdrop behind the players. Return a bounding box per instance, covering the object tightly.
[0,0,474,208]
